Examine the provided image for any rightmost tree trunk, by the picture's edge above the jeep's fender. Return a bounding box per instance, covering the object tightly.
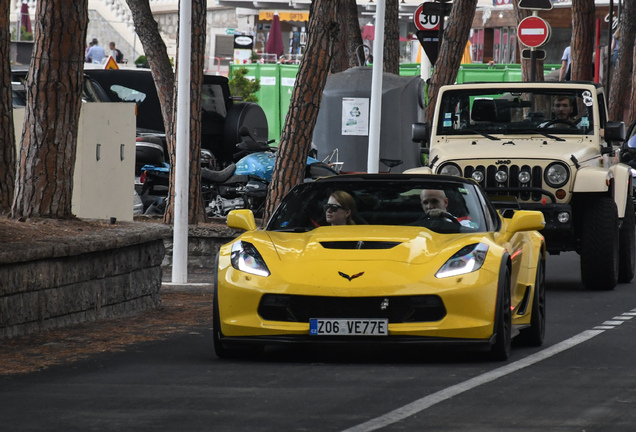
[608,2,636,125]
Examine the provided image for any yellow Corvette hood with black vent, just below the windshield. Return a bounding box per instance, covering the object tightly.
[260,225,483,265]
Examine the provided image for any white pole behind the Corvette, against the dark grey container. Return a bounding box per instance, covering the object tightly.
[367,0,385,174]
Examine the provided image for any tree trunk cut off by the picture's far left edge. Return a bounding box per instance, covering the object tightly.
[0,0,15,213]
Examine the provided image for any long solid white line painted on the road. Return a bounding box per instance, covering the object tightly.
[343,330,605,432]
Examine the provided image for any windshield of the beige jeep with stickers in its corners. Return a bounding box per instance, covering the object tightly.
[436,87,594,136]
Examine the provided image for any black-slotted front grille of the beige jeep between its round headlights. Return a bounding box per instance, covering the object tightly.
[464,165,543,201]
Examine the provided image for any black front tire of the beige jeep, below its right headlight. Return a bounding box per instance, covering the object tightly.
[580,196,619,291]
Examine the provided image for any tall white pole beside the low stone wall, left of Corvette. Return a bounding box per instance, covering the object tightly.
[172,0,192,283]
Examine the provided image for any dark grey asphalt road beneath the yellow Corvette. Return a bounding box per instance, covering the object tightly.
[0,254,636,432]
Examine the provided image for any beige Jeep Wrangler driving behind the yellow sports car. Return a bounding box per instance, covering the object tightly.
[407,82,636,290]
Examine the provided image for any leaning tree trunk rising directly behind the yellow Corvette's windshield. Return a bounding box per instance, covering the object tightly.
[263,0,338,221]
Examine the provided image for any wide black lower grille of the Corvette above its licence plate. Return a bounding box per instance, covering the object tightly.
[258,294,446,323]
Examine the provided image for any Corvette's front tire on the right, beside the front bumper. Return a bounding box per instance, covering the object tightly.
[490,264,512,361]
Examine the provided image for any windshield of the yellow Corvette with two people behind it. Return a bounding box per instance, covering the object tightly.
[267,179,487,234]
